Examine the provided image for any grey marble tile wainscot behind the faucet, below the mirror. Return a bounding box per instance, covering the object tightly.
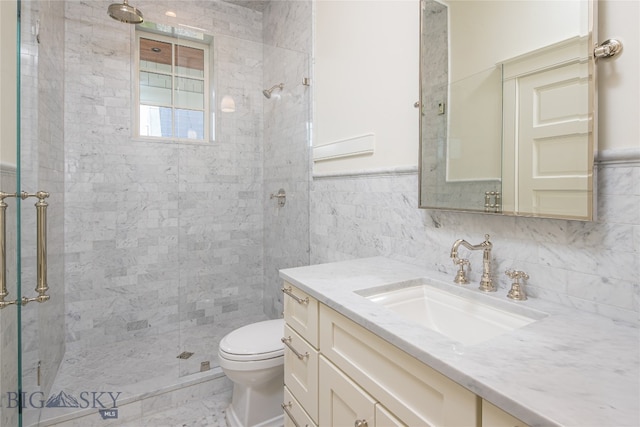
[310,159,640,321]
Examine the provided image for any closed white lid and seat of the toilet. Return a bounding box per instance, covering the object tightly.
[220,319,284,360]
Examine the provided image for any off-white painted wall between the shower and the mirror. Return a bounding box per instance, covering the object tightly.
[313,0,419,173]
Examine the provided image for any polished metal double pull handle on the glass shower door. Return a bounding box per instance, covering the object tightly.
[0,191,50,309]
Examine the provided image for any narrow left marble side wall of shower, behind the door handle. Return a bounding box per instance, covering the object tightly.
[16,1,65,425]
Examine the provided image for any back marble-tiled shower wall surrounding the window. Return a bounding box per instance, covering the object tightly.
[65,0,264,349]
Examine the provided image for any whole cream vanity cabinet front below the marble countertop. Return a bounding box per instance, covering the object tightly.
[283,283,527,427]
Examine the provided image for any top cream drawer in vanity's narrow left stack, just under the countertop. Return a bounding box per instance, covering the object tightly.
[282,282,318,349]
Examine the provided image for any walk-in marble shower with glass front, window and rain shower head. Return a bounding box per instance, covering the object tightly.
[0,0,311,427]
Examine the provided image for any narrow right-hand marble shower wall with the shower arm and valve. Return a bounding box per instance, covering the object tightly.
[262,1,311,317]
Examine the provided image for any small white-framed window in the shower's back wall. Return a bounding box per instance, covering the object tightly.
[136,27,213,141]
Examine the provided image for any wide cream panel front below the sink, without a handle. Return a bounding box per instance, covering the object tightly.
[320,304,480,427]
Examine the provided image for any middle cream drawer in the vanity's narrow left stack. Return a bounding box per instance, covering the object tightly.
[283,324,318,423]
